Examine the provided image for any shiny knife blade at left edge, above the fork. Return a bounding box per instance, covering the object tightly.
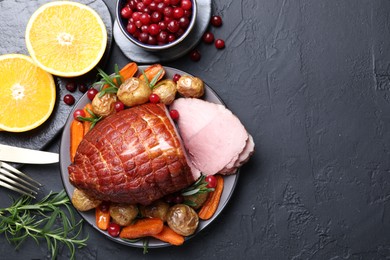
[0,144,59,164]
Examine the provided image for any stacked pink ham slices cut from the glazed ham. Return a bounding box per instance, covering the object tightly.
[171,98,254,175]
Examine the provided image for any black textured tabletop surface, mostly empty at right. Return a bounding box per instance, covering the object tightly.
[0,0,390,259]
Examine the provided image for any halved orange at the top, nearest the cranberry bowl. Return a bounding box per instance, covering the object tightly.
[26,1,107,77]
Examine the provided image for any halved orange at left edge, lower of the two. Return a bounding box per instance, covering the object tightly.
[0,54,56,132]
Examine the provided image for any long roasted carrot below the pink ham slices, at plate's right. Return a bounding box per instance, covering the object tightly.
[198,175,224,220]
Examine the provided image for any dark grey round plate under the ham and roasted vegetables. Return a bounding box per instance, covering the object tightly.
[60,66,238,248]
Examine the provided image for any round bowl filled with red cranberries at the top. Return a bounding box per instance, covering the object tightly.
[116,0,197,51]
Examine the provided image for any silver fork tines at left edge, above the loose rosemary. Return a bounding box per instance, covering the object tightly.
[0,161,42,199]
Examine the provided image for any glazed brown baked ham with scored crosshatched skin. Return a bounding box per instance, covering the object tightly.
[68,103,200,205]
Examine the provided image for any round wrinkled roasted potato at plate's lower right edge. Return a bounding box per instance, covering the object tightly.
[167,204,199,236]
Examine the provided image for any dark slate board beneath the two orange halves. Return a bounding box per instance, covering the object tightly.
[0,0,113,150]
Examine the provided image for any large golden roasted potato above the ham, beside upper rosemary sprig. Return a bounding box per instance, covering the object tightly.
[117,77,152,107]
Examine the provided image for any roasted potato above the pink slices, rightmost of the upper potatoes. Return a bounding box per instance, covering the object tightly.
[176,75,204,98]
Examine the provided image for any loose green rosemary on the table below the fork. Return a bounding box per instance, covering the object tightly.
[0,190,88,259]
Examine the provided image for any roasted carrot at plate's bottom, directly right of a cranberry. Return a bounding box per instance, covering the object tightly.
[119,218,164,239]
